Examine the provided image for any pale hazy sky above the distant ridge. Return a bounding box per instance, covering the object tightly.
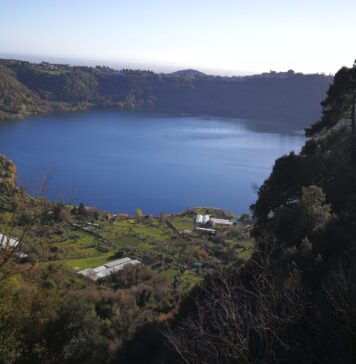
[0,0,356,74]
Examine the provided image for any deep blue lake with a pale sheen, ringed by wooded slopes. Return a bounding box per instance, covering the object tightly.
[0,110,304,215]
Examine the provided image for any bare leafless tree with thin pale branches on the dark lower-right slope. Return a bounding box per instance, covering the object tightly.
[165,250,304,364]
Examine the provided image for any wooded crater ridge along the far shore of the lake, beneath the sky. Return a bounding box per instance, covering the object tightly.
[0,60,332,128]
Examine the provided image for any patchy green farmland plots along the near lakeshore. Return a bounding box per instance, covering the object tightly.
[0,206,254,290]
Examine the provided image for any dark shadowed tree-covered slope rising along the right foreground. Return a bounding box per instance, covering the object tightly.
[163,63,356,364]
